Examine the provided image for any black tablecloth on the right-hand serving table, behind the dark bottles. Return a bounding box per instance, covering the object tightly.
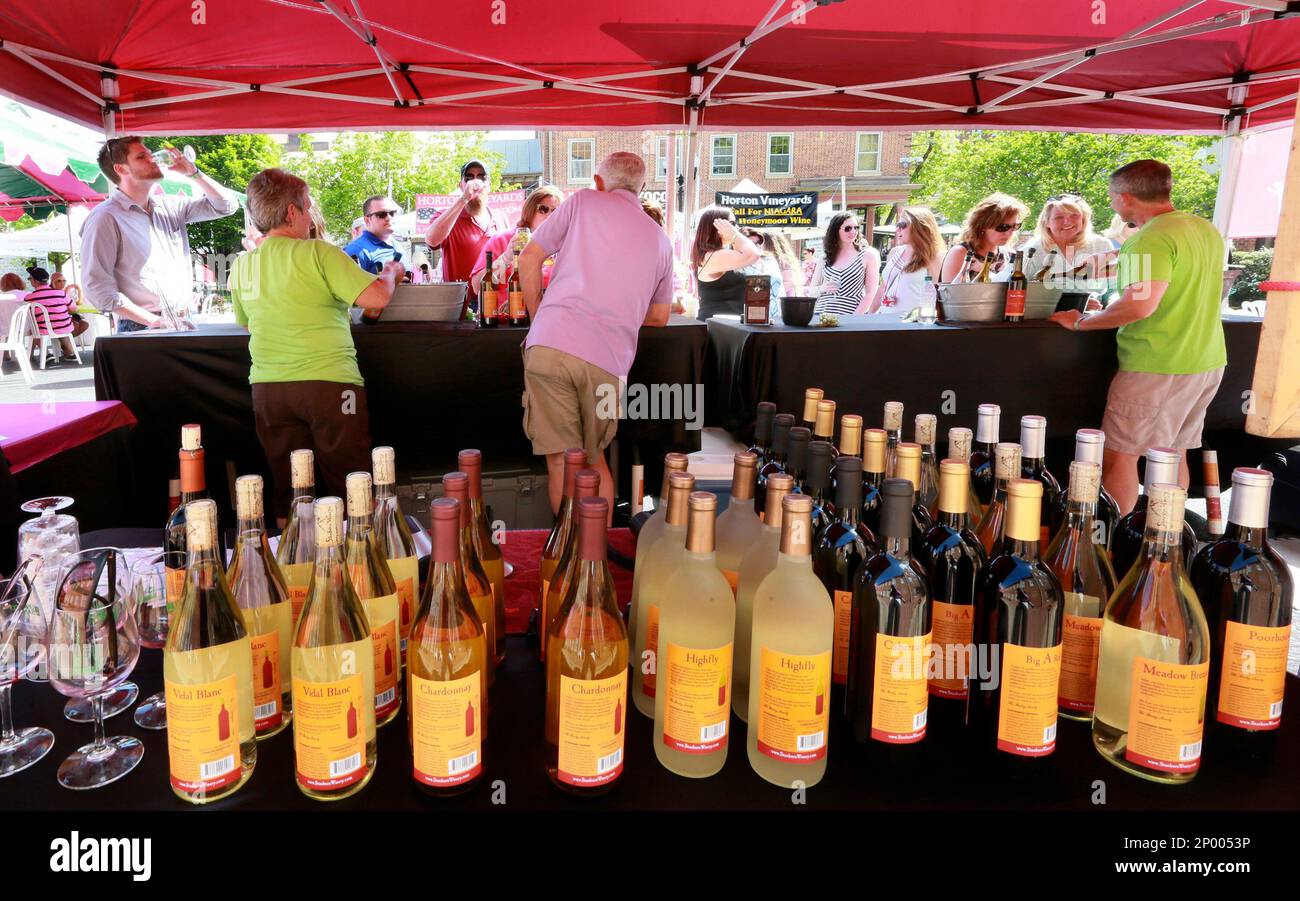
[705,316,1294,484]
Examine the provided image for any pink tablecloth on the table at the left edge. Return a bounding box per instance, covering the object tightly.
[0,400,135,472]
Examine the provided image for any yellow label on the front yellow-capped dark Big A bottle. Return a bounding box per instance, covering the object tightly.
[997,642,1061,757]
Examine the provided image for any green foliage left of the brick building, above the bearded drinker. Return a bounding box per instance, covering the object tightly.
[285,131,506,239]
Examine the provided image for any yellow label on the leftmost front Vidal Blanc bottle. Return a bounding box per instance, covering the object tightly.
[164,670,247,792]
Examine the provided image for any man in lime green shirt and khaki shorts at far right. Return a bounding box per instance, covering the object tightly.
[1052,160,1227,512]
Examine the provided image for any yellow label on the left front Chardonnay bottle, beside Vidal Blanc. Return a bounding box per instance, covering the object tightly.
[408,665,484,788]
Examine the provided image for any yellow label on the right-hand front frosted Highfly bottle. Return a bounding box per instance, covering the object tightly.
[750,647,831,763]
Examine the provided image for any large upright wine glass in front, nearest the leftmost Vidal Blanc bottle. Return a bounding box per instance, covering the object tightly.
[46,547,144,789]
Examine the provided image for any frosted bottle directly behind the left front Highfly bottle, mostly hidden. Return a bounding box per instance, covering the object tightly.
[632,472,696,716]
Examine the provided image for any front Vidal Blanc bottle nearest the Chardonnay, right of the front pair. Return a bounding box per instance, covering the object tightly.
[290,497,377,801]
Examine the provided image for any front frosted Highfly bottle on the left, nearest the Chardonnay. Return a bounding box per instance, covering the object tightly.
[654,491,736,779]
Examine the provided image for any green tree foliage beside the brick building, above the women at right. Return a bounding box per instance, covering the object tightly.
[911,131,1218,231]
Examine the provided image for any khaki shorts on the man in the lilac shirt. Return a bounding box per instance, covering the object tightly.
[524,346,619,460]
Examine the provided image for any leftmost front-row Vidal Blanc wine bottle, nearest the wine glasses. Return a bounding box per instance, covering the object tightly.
[163,499,257,803]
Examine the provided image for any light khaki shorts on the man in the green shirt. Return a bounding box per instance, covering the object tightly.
[1101,367,1223,456]
